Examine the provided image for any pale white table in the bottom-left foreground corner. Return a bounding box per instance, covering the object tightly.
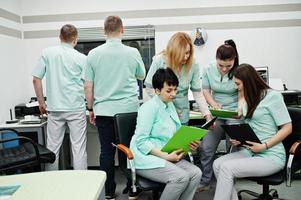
[0,170,106,200]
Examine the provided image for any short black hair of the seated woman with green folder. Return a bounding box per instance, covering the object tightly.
[152,68,179,90]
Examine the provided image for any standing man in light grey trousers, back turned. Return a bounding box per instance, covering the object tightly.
[32,24,87,170]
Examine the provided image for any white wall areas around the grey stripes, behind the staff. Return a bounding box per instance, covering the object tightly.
[0,0,301,122]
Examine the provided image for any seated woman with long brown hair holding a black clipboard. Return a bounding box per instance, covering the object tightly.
[213,64,292,200]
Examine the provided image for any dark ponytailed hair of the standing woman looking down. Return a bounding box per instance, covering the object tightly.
[216,40,239,79]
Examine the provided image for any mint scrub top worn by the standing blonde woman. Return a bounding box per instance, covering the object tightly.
[144,54,202,124]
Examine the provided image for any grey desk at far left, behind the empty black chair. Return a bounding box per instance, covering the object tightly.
[0,121,47,145]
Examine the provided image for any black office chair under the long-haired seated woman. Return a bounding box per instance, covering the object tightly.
[238,107,301,200]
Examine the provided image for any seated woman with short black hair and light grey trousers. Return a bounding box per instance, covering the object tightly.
[130,68,202,200]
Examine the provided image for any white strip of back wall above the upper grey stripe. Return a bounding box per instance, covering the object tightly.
[21,0,300,16]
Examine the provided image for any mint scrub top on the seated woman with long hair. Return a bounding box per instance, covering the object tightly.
[243,89,291,167]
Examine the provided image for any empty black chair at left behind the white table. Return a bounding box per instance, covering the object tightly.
[0,128,55,174]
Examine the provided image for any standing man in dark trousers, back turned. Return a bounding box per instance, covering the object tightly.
[85,16,145,199]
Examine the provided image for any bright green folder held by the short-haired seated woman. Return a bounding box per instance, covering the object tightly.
[161,126,207,153]
